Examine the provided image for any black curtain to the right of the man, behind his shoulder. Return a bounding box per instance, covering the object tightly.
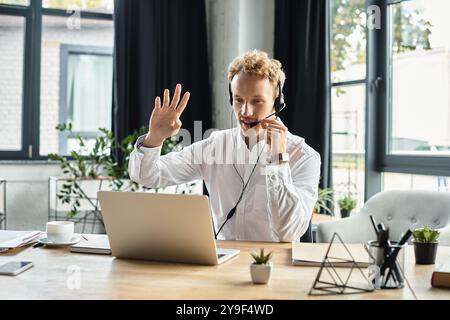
[274,0,332,242]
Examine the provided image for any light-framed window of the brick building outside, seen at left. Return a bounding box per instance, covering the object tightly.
[56,45,113,154]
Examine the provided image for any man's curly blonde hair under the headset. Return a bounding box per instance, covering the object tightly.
[228,49,286,88]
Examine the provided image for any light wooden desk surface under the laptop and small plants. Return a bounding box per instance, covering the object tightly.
[0,241,450,300]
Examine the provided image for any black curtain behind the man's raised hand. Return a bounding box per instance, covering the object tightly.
[113,0,212,145]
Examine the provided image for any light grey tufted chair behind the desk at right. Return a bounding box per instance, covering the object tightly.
[317,190,450,246]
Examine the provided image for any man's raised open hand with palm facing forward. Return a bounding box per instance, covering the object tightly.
[143,84,190,147]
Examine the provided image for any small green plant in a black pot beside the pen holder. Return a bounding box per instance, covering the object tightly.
[413,226,440,264]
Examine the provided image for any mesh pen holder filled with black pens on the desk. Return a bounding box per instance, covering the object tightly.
[368,240,407,289]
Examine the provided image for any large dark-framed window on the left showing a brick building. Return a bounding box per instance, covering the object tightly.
[0,0,114,159]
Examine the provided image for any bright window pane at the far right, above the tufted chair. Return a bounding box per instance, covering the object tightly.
[387,0,450,156]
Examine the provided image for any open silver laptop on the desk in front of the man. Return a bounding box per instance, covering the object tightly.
[98,191,239,265]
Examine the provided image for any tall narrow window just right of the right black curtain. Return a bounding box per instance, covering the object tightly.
[330,0,366,212]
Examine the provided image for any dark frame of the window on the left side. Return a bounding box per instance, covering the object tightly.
[0,0,114,161]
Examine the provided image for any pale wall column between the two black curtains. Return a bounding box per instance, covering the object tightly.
[206,0,275,129]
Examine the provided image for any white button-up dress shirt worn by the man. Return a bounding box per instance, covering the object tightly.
[128,128,321,242]
